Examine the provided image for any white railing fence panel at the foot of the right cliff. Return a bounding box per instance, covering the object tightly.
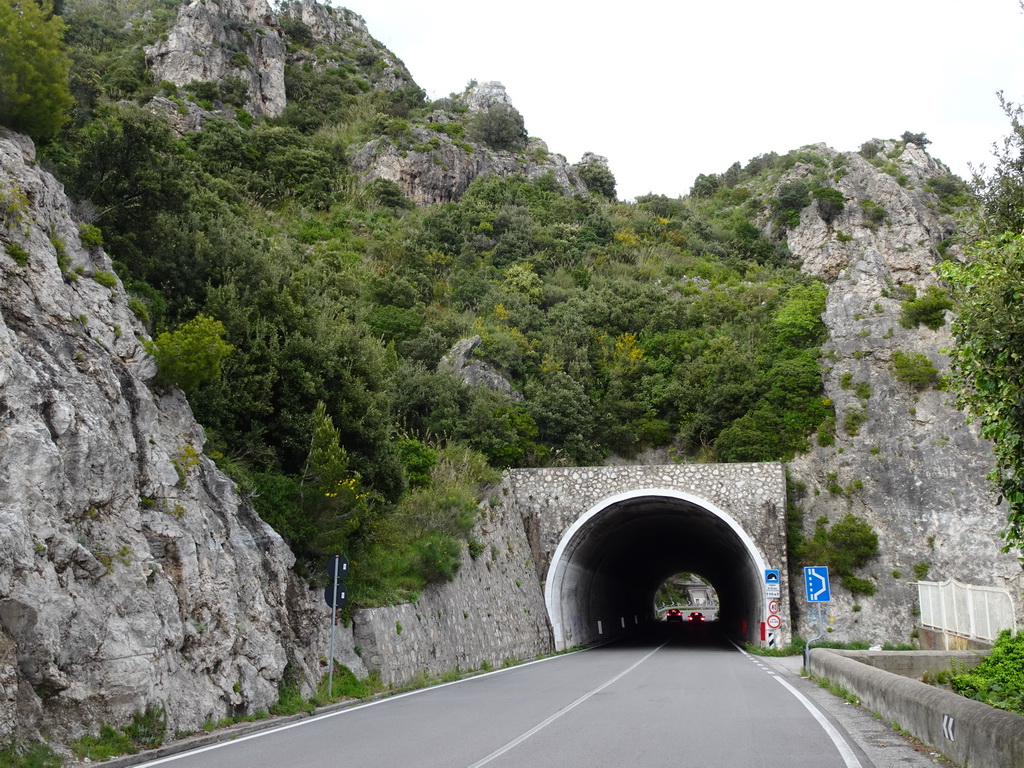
[918,579,1017,640]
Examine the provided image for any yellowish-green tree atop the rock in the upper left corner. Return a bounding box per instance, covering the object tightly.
[0,0,74,141]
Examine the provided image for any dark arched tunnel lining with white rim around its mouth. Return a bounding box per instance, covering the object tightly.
[545,490,766,650]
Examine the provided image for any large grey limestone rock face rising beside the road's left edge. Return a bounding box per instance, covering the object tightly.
[0,131,327,743]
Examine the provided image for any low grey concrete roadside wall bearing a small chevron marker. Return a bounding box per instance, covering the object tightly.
[809,648,1024,768]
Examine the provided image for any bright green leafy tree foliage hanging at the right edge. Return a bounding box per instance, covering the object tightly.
[940,232,1024,551]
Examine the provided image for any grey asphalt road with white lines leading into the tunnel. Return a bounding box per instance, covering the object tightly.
[134,625,888,768]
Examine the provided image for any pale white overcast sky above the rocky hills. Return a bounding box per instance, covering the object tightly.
[342,0,1024,200]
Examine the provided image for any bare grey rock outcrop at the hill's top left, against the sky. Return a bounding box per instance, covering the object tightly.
[145,0,286,117]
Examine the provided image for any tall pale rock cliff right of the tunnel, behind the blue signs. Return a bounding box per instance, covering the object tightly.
[783,141,1024,642]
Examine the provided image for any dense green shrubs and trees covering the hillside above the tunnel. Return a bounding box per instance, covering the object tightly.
[4,0,876,604]
